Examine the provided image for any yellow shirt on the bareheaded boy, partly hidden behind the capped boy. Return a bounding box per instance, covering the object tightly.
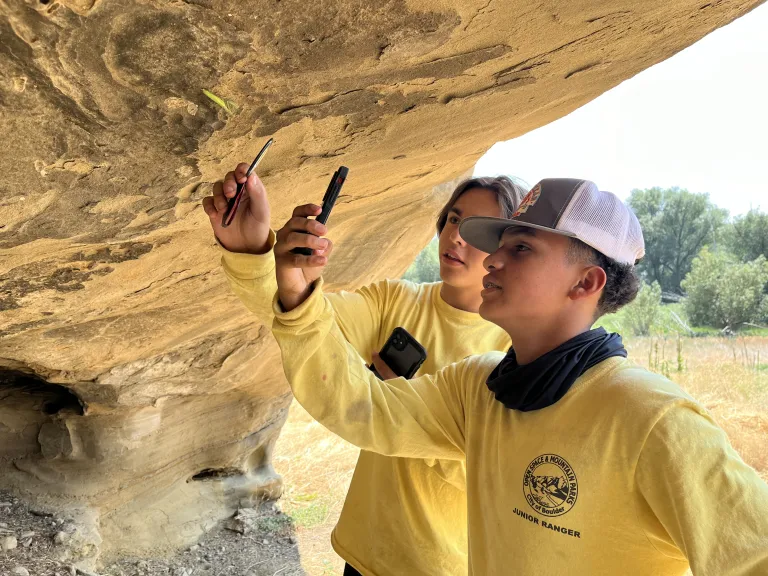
[222,236,510,576]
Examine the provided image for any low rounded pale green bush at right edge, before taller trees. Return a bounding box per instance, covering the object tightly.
[683,248,768,328]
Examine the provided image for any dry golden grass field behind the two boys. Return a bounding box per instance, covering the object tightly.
[275,337,768,576]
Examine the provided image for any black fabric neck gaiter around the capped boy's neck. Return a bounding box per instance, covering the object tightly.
[486,328,627,412]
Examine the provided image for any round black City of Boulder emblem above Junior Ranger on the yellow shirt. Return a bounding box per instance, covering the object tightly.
[523,454,579,516]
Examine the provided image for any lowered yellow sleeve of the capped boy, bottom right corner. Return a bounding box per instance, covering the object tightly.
[635,403,768,576]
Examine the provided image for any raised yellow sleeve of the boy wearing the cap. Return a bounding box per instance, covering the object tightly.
[272,280,465,460]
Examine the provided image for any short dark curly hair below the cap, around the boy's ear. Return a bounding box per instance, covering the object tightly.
[567,238,640,320]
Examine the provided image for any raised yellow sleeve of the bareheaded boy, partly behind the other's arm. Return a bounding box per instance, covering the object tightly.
[220,230,392,362]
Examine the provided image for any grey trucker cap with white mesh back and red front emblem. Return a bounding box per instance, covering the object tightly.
[459,178,645,265]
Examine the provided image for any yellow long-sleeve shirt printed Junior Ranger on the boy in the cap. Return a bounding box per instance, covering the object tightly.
[273,282,768,576]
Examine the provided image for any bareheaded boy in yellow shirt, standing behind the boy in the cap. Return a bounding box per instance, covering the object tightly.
[204,164,525,576]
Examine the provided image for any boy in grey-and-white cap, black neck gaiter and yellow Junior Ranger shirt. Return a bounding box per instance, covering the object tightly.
[273,179,768,576]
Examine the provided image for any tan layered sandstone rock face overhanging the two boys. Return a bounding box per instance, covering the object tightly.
[0,0,760,556]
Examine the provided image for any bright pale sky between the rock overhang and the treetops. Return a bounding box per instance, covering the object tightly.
[475,4,768,215]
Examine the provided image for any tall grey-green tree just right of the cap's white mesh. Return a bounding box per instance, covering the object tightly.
[629,188,728,294]
